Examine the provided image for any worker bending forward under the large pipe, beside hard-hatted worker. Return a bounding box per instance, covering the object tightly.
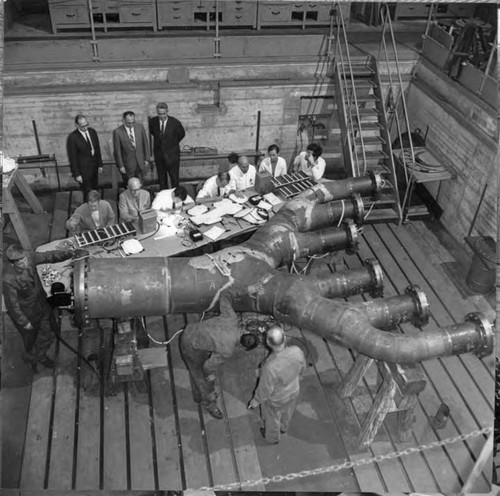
[179,291,240,419]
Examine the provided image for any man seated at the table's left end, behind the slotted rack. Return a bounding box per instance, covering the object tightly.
[66,190,116,233]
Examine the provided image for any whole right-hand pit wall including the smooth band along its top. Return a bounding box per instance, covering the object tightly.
[407,61,498,242]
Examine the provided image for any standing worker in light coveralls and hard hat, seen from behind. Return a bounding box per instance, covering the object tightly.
[248,325,306,444]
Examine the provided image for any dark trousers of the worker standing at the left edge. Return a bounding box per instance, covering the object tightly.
[16,305,57,362]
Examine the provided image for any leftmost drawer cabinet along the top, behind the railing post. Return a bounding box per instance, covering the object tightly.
[49,0,156,33]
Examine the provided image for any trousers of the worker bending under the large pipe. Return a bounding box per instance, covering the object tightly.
[179,331,216,406]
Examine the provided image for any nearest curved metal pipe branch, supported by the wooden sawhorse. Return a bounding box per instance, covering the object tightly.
[256,273,494,363]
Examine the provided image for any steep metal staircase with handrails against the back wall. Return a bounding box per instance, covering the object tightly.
[333,3,413,224]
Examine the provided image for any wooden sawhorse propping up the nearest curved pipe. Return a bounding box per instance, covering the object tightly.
[340,355,427,446]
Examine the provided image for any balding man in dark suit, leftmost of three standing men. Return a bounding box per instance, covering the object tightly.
[66,114,103,201]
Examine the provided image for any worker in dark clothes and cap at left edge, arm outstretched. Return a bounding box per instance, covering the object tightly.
[3,245,74,370]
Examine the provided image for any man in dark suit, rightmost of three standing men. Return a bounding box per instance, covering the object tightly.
[149,102,186,190]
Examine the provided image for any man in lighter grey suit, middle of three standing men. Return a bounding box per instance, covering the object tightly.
[113,110,151,184]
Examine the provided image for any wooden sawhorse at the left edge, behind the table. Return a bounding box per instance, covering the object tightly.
[2,169,44,250]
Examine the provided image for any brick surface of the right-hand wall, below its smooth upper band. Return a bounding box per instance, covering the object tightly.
[407,82,498,241]
